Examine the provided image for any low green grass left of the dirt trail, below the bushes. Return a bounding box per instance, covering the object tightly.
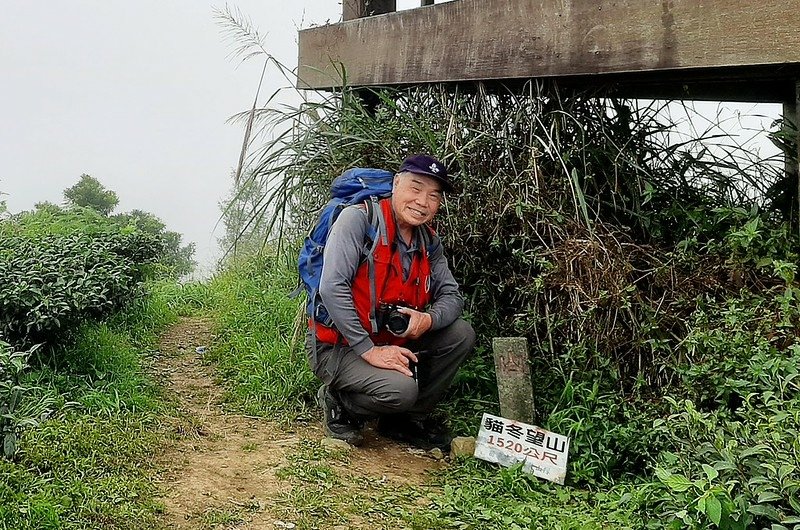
[0,278,179,530]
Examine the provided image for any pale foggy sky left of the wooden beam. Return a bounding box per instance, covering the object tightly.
[0,0,341,276]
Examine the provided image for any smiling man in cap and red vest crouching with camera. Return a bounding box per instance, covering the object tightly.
[306,155,475,449]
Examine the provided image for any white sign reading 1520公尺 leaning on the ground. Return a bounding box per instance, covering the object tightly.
[475,414,569,484]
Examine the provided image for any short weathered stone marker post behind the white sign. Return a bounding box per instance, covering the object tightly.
[492,337,534,423]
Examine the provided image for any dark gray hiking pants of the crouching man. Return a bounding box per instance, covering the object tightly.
[306,318,475,419]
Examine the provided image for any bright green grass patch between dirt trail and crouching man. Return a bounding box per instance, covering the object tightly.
[209,252,316,419]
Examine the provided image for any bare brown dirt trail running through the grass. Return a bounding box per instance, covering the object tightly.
[155,318,438,530]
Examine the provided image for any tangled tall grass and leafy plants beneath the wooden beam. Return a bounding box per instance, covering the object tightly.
[228,65,800,528]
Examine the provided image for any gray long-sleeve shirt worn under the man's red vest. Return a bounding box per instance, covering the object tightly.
[319,202,464,355]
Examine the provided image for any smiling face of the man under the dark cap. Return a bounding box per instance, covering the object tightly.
[392,173,442,228]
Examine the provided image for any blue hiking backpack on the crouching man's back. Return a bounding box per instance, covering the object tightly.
[297,167,394,326]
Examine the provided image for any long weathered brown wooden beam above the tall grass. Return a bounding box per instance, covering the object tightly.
[298,0,800,101]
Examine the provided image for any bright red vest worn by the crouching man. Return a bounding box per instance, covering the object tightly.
[310,198,431,345]
